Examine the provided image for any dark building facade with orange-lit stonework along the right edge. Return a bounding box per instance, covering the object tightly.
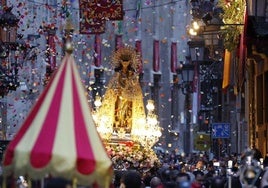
[245,0,268,155]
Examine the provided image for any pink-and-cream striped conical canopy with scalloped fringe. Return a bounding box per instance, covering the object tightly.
[3,54,113,187]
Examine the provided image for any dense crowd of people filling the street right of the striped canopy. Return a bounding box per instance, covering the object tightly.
[113,149,268,188]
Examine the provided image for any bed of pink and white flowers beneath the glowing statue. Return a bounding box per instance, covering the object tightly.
[106,141,160,171]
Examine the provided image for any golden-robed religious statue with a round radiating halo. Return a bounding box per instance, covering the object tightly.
[96,46,145,138]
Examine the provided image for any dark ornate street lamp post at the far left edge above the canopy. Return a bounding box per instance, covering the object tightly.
[0,7,25,140]
